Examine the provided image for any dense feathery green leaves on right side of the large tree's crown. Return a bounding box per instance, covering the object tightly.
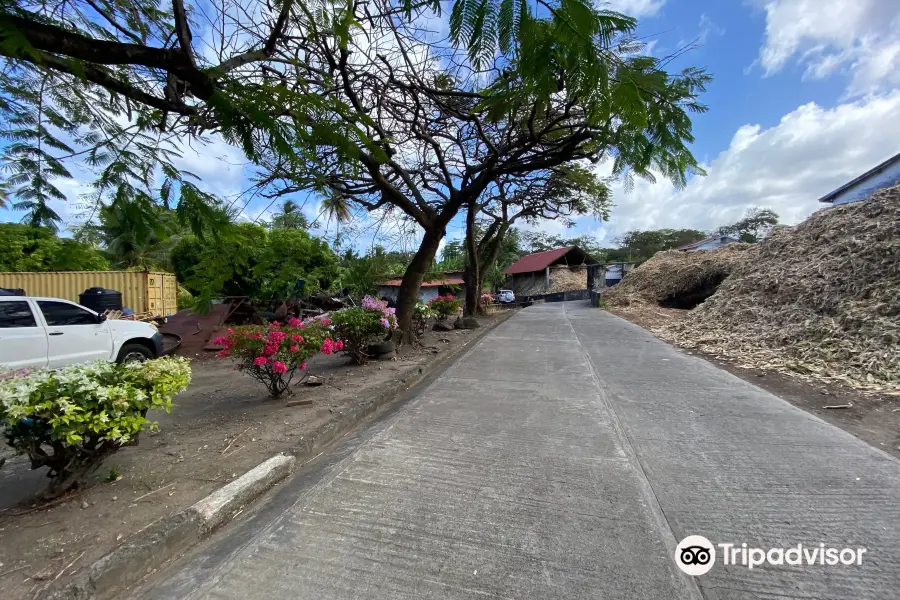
[450,0,710,187]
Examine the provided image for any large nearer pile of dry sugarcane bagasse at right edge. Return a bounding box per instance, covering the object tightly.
[652,186,900,395]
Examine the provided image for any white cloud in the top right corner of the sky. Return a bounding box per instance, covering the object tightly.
[759,0,900,96]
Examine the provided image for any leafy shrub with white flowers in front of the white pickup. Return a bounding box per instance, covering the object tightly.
[0,358,191,498]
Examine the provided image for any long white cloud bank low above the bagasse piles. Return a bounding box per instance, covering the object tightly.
[579,90,900,238]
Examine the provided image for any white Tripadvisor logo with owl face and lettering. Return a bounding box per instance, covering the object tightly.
[675,535,867,577]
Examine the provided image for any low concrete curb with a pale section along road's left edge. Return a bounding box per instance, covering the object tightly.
[40,310,517,600]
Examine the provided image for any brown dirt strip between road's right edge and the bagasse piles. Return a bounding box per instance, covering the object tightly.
[606,305,900,458]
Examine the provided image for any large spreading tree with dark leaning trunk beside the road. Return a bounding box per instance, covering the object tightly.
[255,0,707,338]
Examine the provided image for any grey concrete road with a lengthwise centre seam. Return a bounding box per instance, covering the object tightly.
[135,303,900,600]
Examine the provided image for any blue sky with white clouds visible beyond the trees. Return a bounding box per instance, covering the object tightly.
[0,0,900,253]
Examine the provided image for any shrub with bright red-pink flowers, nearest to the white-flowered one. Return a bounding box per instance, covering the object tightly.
[213,317,343,398]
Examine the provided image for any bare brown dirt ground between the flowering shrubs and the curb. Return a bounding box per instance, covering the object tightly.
[0,315,503,600]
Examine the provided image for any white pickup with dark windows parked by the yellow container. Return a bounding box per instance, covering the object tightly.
[0,296,163,369]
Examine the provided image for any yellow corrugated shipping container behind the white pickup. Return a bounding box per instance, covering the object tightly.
[0,271,178,316]
